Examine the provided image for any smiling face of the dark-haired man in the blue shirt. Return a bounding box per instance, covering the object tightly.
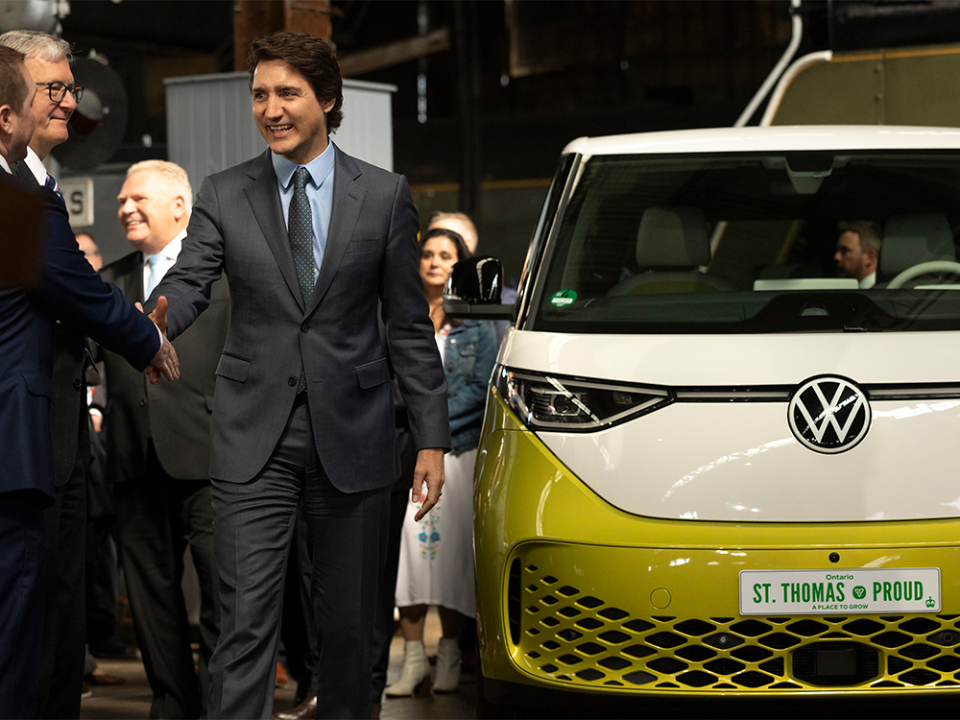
[251,60,336,165]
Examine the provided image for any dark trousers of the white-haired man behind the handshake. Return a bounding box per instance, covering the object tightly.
[117,442,220,720]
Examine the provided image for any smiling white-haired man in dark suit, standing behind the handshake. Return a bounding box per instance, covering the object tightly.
[101,160,230,720]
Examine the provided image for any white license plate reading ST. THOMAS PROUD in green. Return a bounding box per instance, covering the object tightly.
[740,568,940,615]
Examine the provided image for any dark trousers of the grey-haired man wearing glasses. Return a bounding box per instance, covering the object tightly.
[35,444,89,720]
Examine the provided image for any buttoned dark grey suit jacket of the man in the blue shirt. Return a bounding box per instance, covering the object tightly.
[148,148,450,492]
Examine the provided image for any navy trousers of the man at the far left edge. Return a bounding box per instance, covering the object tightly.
[0,492,47,720]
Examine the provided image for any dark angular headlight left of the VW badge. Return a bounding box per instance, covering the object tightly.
[494,366,674,432]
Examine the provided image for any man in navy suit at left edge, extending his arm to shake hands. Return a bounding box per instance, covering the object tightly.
[0,45,177,720]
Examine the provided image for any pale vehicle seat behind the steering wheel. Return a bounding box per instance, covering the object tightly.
[880,214,957,280]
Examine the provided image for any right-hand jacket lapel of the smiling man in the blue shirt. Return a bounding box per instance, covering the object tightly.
[307,148,367,315]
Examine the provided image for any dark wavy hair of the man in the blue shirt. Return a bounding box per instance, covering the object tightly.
[247,30,343,133]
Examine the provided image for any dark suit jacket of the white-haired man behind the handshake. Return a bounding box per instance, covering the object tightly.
[100,251,230,482]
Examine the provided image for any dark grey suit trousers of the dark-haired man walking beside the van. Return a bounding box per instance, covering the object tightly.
[208,395,390,720]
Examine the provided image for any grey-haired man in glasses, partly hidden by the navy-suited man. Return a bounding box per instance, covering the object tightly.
[0,30,104,720]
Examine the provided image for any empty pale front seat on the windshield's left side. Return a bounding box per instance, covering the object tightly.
[608,206,733,295]
